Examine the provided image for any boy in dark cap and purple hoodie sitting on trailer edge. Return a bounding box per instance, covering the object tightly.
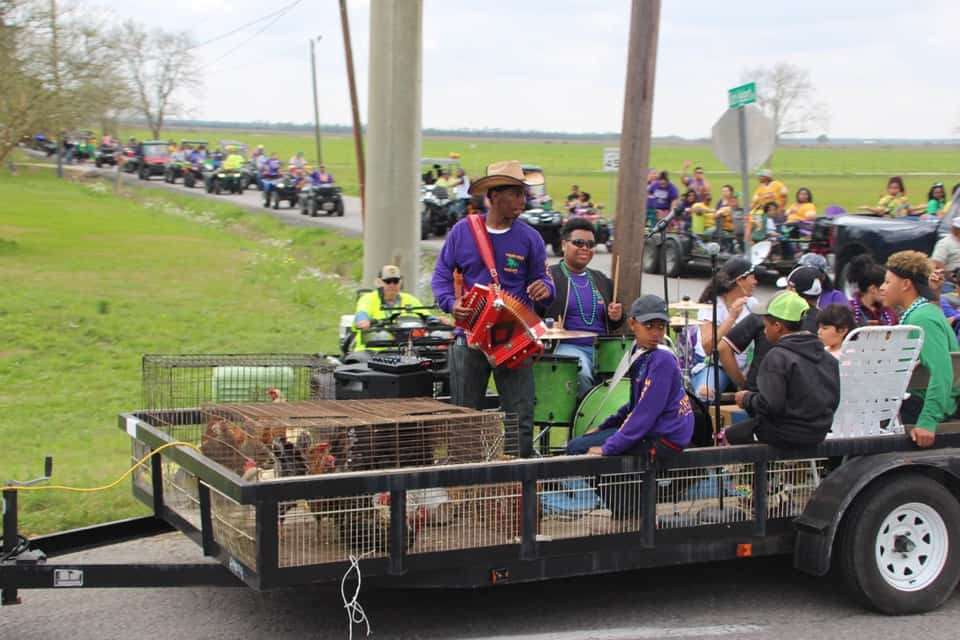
[567,295,694,464]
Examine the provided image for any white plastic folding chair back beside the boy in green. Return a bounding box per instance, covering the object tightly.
[827,325,923,438]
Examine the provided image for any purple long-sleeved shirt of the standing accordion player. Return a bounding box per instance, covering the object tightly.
[431,217,556,313]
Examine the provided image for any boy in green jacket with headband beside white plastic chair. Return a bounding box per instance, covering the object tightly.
[880,251,960,447]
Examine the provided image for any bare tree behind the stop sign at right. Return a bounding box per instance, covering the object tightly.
[743,62,830,140]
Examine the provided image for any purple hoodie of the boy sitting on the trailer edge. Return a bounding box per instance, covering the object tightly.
[599,347,693,456]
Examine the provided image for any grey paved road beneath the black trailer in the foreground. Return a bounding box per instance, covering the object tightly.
[0,534,960,640]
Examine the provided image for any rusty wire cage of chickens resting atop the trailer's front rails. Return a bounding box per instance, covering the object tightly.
[189,399,518,480]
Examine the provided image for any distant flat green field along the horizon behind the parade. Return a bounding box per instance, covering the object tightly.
[123,129,960,209]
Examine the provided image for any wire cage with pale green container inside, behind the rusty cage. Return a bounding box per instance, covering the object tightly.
[142,353,336,409]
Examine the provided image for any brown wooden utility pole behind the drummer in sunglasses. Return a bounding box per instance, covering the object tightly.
[613,0,660,307]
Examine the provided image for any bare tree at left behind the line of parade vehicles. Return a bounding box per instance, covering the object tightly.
[117,21,199,139]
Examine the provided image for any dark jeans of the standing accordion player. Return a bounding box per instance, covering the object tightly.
[449,336,534,458]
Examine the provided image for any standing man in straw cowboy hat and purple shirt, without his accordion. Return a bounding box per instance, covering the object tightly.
[431,161,555,457]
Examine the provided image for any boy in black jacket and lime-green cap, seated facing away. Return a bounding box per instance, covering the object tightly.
[725,291,840,448]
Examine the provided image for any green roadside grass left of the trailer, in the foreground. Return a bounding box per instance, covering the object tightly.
[0,169,362,534]
